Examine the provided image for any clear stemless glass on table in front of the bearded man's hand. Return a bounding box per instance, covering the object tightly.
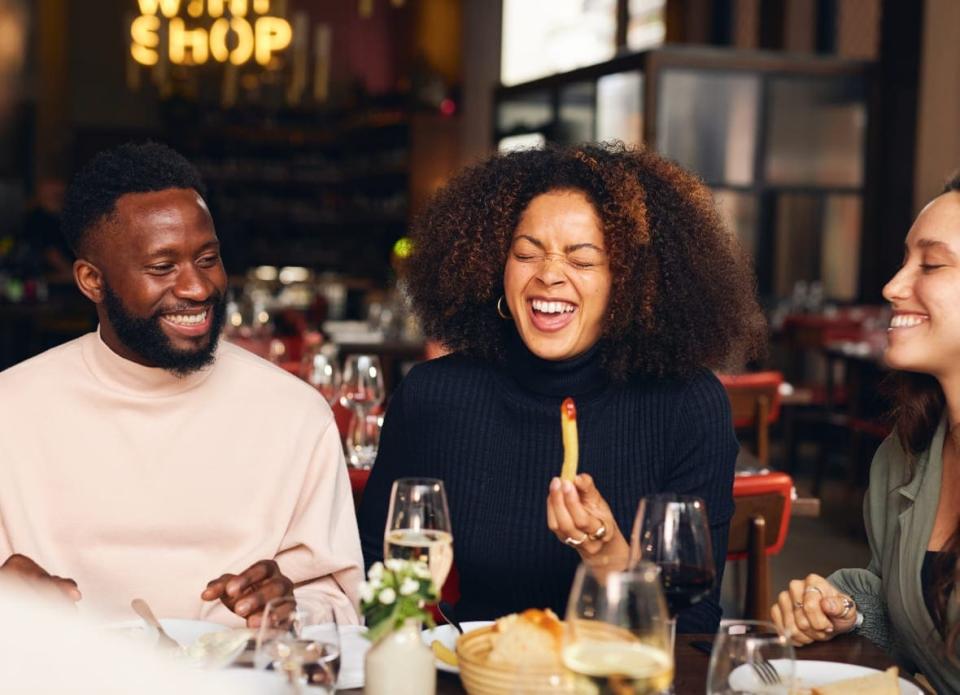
[254,596,340,693]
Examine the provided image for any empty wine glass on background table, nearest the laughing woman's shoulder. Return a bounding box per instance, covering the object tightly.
[340,355,385,468]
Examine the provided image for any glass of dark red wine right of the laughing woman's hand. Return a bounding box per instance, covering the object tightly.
[630,493,716,656]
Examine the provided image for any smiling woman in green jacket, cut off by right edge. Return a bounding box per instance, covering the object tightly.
[771,174,960,693]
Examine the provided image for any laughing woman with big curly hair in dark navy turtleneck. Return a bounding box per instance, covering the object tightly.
[360,145,764,632]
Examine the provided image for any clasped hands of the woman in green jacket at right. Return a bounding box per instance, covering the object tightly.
[770,574,857,647]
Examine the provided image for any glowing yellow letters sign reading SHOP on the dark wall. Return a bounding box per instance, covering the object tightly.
[130,0,293,66]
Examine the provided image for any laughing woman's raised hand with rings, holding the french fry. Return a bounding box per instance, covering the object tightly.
[547,473,630,568]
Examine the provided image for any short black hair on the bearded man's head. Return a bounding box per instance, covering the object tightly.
[63,142,206,256]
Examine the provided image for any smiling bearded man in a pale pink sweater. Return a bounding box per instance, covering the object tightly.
[0,143,362,626]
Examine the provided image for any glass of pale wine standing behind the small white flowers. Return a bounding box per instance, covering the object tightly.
[383,478,453,592]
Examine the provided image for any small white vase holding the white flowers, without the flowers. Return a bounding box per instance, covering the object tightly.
[363,620,437,695]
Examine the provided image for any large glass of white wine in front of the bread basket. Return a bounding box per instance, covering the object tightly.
[563,562,673,695]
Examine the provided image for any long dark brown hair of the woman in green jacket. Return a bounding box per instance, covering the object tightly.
[888,170,960,659]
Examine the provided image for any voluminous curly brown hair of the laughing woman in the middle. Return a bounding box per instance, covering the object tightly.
[406,143,766,380]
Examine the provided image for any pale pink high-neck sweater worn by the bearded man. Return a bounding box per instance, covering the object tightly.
[0,333,363,625]
